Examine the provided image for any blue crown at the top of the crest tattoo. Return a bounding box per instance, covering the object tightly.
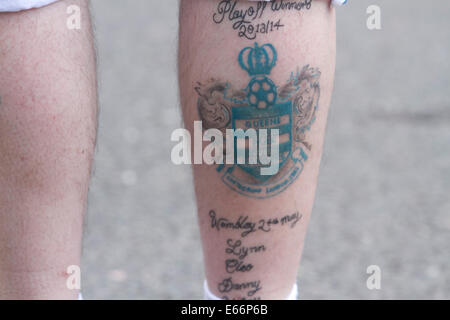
[239,42,277,77]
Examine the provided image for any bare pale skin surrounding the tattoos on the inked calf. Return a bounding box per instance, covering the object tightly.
[179,0,336,299]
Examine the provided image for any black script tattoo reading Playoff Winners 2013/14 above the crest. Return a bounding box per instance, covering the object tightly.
[212,0,312,40]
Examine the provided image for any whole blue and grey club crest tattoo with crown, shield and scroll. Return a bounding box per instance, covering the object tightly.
[195,43,320,198]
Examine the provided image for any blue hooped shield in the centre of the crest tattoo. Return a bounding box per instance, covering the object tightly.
[232,101,292,182]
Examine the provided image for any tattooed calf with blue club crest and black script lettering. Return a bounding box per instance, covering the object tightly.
[179,0,335,299]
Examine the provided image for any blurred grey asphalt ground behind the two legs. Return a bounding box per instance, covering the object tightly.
[82,0,450,299]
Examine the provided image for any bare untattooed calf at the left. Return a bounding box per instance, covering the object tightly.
[0,0,97,299]
